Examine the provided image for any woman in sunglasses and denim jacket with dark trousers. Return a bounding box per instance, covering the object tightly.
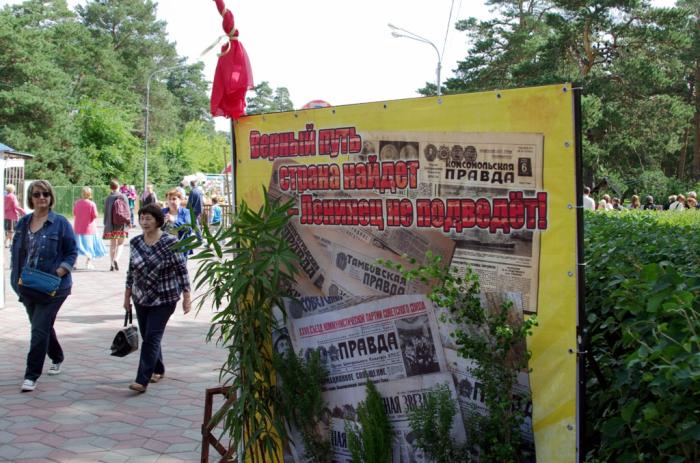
[10,180,78,392]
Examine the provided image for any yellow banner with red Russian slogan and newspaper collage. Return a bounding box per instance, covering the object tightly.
[235,84,578,462]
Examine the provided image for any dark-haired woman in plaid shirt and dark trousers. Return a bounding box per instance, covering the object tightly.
[124,204,192,392]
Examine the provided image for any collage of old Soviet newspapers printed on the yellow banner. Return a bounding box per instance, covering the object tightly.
[269,132,546,462]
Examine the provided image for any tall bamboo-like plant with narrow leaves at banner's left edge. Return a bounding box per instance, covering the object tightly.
[183,191,298,462]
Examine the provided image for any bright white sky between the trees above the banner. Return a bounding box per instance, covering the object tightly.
[0,0,675,129]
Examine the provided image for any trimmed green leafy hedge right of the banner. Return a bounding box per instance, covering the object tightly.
[584,211,700,462]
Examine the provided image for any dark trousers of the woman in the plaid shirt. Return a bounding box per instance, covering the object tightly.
[134,302,176,386]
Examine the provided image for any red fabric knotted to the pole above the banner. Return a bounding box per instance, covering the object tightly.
[211,0,253,119]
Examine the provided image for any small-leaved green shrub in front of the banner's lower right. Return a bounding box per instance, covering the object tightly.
[380,251,537,463]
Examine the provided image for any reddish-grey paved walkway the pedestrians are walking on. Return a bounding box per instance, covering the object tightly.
[0,229,225,463]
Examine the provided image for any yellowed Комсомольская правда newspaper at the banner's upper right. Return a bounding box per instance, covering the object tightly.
[364,132,544,313]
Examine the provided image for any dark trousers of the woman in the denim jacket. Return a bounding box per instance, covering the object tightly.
[22,295,68,381]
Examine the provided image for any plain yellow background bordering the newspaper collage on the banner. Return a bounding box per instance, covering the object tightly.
[234,84,577,462]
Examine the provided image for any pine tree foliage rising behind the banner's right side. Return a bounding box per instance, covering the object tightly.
[426,0,700,191]
